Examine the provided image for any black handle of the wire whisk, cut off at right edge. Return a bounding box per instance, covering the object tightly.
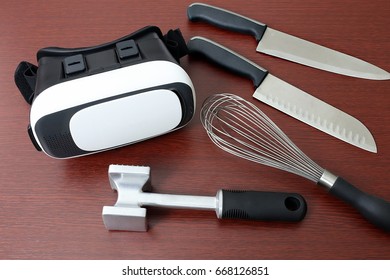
[329,177,390,232]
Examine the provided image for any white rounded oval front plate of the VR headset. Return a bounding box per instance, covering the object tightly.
[70,89,183,151]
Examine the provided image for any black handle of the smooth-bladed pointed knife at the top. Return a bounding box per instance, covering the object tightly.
[187,3,267,41]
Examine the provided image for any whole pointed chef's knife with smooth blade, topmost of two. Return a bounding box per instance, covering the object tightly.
[187,3,390,80]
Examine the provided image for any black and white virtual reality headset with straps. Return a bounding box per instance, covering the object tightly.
[15,26,195,158]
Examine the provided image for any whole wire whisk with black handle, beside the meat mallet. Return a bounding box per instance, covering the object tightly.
[200,93,390,231]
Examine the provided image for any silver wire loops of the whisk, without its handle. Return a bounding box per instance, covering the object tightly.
[201,94,324,183]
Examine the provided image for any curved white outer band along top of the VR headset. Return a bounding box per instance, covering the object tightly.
[30,61,194,128]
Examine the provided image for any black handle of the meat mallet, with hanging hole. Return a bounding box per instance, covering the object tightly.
[222,190,307,222]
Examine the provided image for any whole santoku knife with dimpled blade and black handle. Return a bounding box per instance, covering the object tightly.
[187,37,377,153]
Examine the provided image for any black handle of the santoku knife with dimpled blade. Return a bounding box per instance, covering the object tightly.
[187,37,268,88]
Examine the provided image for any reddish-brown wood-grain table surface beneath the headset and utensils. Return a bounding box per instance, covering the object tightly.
[0,0,390,259]
